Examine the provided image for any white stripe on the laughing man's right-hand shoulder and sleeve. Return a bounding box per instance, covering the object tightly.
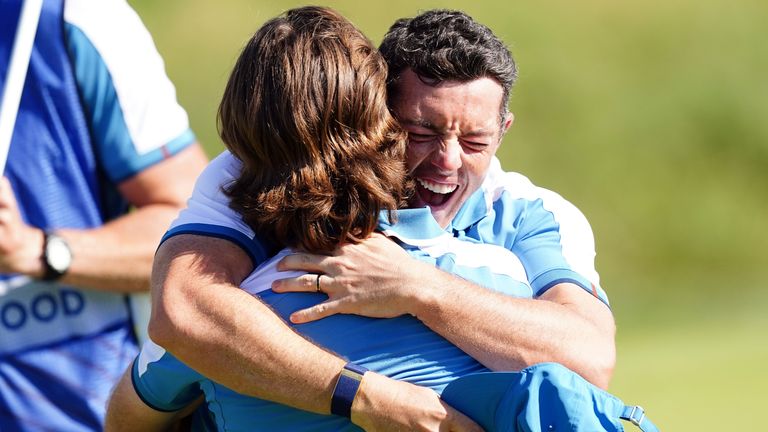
[482,157,600,286]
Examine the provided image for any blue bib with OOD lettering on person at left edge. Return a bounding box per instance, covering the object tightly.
[0,0,137,431]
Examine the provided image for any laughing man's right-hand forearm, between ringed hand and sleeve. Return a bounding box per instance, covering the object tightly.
[411,266,615,388]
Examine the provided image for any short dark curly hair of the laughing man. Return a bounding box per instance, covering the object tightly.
[379,9,517,118]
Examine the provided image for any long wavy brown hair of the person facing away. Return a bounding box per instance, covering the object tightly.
[218,7,410,252]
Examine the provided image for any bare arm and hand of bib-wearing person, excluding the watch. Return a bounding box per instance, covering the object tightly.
[0,144,207,292]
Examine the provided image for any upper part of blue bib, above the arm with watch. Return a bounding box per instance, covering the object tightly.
[0,0,106,228]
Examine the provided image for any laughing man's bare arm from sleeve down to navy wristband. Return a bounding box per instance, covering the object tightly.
[149,236,345,414]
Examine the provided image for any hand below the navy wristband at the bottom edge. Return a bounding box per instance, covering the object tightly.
[352,372,483,432]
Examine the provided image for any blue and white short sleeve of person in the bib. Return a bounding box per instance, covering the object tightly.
[64,0,195,183]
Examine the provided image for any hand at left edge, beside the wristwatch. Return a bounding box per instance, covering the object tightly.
[0,177,43,275]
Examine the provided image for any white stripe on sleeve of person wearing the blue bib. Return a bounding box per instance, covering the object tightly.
[64,0,189,154]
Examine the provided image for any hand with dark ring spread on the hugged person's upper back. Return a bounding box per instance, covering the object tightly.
[272,233,435,324]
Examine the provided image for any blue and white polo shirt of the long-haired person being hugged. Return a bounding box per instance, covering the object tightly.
[134,209,531,431]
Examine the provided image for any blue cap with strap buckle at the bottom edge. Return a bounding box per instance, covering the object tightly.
[442,363,658,432]
